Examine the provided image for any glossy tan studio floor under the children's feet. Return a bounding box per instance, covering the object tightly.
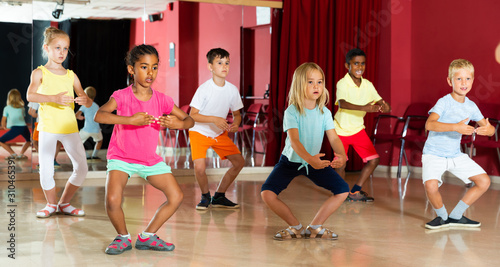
[0,173,500,266]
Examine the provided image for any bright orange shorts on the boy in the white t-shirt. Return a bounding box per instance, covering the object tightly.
[189,131,241,160]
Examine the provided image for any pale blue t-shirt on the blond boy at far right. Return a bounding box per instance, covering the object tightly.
[423,94,484,158]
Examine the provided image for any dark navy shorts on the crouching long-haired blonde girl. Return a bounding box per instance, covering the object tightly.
[262,155,349,195]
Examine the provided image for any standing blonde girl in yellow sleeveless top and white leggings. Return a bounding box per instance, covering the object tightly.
[27,27,92,218]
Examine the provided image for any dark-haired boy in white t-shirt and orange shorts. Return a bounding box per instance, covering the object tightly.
[189,48,245,210]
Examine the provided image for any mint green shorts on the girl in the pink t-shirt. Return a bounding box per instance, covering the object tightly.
[106,159,172,179]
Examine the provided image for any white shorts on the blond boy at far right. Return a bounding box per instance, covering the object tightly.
[422,154,486,186]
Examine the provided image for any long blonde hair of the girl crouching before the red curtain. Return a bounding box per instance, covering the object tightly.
[288,62,330,115]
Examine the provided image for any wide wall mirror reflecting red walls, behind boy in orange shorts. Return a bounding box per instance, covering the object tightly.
[26,0,271,171]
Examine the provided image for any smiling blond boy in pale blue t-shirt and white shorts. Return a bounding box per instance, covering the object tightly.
[422,59,495,229]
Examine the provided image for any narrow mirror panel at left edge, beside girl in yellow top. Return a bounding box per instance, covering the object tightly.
[0,0,33,174]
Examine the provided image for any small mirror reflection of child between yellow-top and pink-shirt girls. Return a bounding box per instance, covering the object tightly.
[76,86,103,160]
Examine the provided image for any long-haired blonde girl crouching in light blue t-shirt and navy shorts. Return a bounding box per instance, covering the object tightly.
[261,63,349,240]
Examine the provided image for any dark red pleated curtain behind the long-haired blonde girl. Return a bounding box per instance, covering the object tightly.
[266,0,381,170]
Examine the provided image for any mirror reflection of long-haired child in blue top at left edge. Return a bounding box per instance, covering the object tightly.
[0,89,31,159]
